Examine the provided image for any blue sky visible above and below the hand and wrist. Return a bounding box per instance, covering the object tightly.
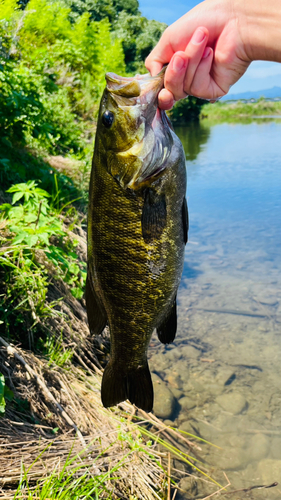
[139,0,281,94]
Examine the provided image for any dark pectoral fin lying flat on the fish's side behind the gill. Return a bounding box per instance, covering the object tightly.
[141,188,167,243]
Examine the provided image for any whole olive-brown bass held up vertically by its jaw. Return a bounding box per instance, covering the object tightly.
[85,69,188,412]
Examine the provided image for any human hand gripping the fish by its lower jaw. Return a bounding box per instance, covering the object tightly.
[146,0,251,109]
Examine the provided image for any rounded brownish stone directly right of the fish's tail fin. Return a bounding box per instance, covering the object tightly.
[151,373,176,419]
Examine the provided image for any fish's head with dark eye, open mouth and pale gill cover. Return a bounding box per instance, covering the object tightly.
[98,68,173,190]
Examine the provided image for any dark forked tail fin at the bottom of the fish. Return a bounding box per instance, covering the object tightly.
[101,361,153,412]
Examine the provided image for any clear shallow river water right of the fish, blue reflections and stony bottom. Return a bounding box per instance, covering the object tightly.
[150,121,281,500]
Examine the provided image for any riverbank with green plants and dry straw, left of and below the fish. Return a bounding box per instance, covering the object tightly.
[0,146,217,500]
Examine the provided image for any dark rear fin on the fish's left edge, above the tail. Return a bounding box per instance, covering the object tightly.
[85,270,107,335]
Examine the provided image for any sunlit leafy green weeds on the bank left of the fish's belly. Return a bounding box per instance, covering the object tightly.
[0,181,86,348]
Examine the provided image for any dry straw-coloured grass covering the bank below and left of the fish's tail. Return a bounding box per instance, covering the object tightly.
[0,197,214,500]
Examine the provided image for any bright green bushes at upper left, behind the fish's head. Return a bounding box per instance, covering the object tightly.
[0,0,125,154]
